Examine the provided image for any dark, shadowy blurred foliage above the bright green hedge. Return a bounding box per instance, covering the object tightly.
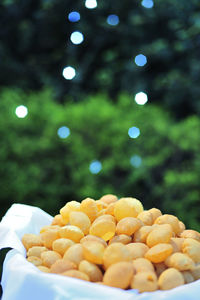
[0,0,200,119]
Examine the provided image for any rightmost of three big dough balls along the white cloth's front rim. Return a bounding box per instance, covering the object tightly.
[158,268,184,290]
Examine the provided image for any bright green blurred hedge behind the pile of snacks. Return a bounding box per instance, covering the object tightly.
[0,89,200,230]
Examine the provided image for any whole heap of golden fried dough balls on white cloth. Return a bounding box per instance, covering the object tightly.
[22,194,200,293]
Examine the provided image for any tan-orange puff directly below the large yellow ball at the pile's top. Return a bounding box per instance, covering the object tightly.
[116,217,142,235]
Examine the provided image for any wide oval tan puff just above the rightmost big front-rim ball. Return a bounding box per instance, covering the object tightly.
[165,252,195,271]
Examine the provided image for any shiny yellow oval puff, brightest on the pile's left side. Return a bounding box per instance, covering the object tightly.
[59,225,84,243]
